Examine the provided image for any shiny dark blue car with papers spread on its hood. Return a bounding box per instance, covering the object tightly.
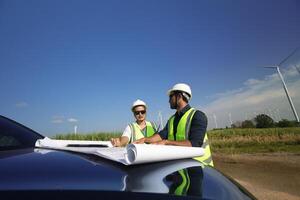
[0,116,255,200]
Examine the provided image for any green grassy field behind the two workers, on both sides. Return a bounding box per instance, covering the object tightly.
[54,128,300,154]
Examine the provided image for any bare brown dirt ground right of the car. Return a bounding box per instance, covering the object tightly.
[213,153,300,200]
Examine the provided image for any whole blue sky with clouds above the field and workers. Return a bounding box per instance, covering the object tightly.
[0,0,300,136]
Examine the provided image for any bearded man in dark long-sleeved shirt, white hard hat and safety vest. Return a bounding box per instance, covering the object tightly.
[134,83,213,166]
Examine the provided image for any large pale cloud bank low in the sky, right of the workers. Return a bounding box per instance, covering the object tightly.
[202,67,300,128]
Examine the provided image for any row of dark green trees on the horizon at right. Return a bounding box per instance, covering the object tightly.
[231,114,300,128]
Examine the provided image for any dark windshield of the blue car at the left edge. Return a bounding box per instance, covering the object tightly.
[0,116,43,150]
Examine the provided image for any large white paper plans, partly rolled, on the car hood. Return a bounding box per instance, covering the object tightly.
[36,138,204,165]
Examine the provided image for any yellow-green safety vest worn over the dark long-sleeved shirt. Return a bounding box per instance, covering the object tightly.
[168,108,214,166]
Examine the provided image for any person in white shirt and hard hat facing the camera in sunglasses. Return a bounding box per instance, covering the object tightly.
[111,99,156,147]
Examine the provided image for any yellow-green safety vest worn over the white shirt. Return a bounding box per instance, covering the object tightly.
[129,121,156,142]
